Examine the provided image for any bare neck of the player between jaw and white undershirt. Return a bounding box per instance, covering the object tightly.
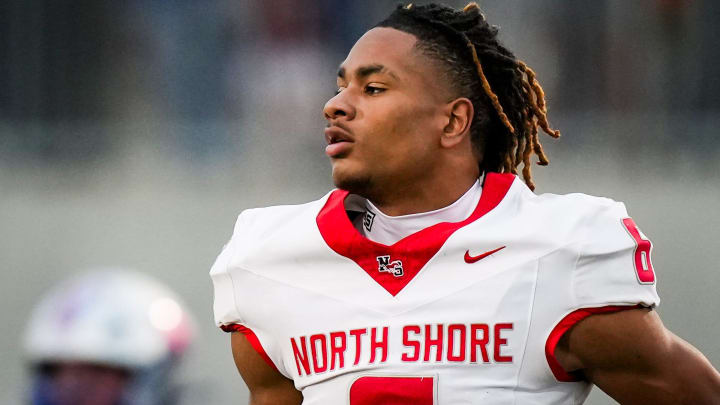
[368,176,477,217]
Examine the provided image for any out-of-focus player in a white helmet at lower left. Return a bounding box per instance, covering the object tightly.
[25,270,192,405]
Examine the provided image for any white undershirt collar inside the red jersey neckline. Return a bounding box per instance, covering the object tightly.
[345,181,482,245]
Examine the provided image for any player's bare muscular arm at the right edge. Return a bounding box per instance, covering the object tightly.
[555,308,720,405]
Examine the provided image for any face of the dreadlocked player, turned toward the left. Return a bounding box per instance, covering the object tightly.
[323,28,449,197]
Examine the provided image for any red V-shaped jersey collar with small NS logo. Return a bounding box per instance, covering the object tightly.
[316,173,515,296]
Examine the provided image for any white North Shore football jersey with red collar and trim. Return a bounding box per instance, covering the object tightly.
[211,173,659,405]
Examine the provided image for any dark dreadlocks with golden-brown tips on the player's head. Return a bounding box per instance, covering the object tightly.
[376,2,560,190]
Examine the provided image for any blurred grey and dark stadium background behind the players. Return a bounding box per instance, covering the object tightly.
[0,0,720,405]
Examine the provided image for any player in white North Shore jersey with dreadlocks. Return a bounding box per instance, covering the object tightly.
[211,3,720,405]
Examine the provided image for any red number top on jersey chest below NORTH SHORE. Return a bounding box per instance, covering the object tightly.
[350,376,435,405]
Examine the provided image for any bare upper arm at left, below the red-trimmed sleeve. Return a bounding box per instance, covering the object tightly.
[230,332,302,405]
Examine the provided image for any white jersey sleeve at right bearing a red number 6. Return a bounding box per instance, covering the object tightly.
[572,201,660,308]
